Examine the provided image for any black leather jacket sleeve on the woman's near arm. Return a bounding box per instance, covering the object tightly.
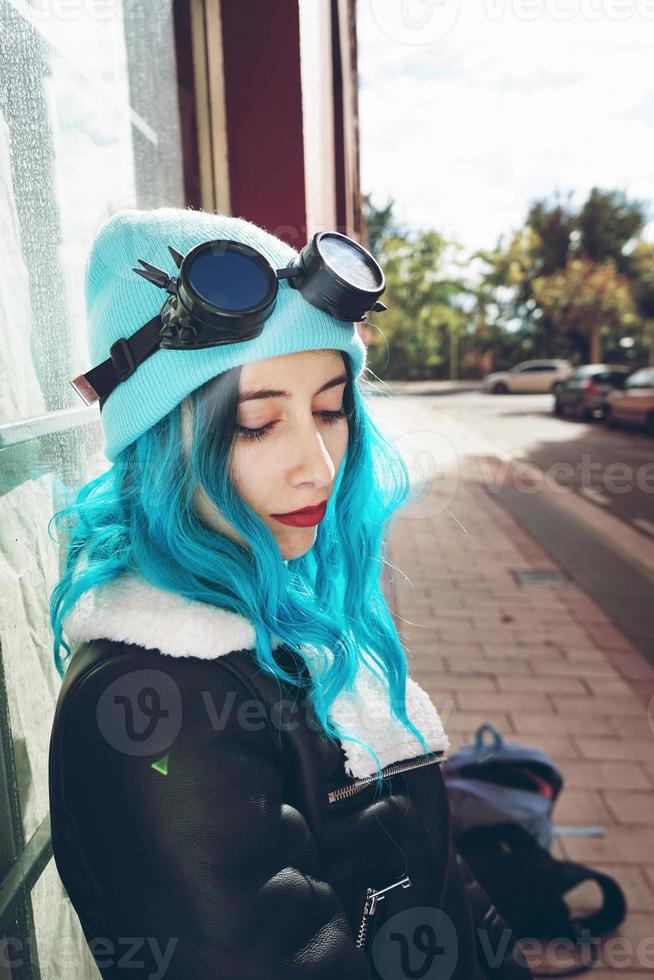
[55,658,371,980]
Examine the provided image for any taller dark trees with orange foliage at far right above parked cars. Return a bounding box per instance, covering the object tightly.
[476,188,654,366]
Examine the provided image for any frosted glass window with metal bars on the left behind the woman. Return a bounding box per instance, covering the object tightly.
[0,0,186,980]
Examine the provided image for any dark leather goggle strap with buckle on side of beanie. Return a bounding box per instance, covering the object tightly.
[70,313,161,410]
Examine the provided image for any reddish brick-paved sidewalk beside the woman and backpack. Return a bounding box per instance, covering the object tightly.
[386,473,654,980]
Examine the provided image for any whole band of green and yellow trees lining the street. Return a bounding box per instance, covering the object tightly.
[364,188,654,379]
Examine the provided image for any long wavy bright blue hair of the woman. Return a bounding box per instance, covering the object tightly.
[48,355,429,787]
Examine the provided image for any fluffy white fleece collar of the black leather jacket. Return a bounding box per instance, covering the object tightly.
[64,572,450,778]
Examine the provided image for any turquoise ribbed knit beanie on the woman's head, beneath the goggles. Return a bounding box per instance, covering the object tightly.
[85,207,366,460]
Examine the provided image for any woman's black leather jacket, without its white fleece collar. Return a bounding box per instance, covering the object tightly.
[49,572,531,980]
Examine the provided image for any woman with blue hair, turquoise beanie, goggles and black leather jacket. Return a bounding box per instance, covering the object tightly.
[50,208,530,980]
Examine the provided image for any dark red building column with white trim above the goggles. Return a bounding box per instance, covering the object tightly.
[220,0,359,249]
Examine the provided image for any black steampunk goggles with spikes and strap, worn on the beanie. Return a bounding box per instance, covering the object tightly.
[70,231,387,410]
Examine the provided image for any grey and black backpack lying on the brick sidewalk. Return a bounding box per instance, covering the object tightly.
[443,723,626,977]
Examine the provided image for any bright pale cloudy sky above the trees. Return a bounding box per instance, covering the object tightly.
[357,0,654,264]
